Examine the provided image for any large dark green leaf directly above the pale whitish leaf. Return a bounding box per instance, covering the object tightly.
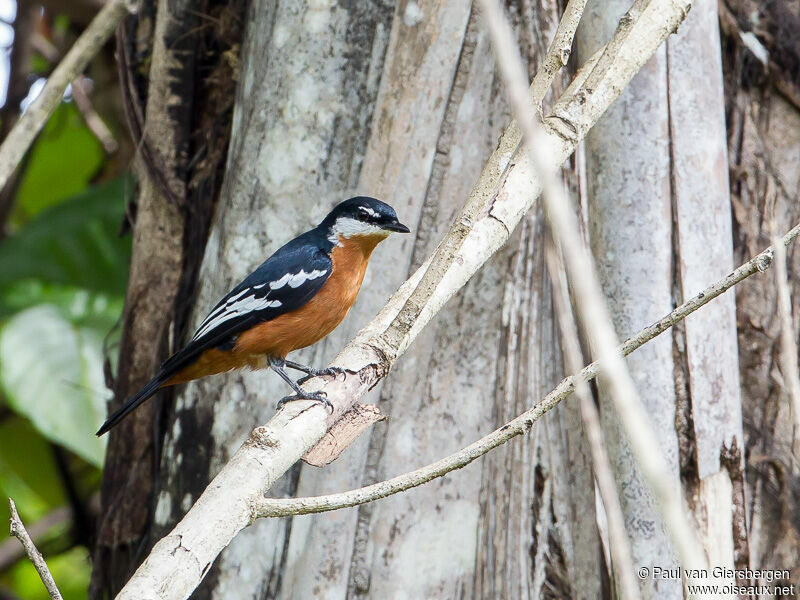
[0,178,131,296]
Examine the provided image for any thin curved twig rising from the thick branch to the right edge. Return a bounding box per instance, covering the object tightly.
[252,224,800,519]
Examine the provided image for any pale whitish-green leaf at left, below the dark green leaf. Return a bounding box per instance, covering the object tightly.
[0,305,109,467]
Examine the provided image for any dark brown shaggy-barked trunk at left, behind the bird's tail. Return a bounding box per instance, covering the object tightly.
[91,0,241,597]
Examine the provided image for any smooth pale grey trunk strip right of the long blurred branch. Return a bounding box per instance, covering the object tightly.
[577,2,683,598]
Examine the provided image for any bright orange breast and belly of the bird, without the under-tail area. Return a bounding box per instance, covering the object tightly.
[234,237,383,357]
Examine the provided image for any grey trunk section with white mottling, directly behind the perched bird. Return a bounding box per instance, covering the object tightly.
[149,1,396,598]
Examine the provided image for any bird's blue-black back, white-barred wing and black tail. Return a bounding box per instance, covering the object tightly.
[97,230,333,435]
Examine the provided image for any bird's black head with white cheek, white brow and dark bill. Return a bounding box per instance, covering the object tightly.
[320,196,409,237]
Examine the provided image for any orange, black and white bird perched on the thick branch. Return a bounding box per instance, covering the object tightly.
[97,196,410,436]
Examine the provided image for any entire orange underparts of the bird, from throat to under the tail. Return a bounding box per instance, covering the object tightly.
[162,235,385,387]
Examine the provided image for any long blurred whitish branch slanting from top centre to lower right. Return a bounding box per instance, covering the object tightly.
[481,0,706,568]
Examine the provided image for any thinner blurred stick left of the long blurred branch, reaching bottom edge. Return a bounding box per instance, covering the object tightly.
[545,244,641,600]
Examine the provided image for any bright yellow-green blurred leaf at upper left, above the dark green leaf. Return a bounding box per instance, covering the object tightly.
[11,102,103,226]
